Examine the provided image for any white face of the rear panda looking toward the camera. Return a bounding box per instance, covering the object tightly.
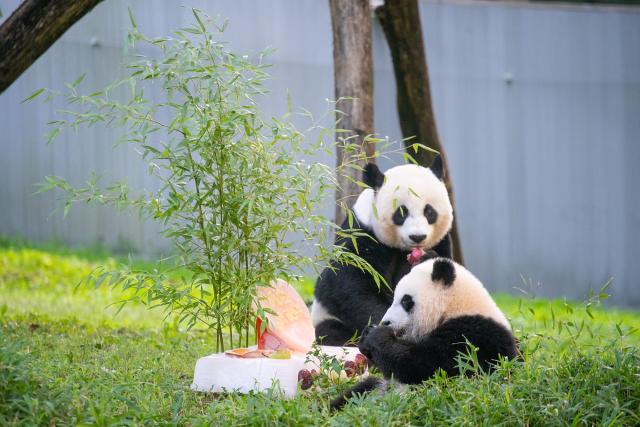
[354,165,453,250]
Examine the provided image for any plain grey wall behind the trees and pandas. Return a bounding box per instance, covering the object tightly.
[0,0,640,306]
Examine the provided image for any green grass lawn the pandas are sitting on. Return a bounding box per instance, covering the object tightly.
[0,242,640,426]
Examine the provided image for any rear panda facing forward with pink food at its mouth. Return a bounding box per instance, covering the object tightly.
[311,156,453,345]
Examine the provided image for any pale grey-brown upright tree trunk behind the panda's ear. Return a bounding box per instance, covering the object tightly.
[329,0,375,225]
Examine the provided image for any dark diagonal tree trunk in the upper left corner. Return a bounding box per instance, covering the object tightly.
[0,0,101,93]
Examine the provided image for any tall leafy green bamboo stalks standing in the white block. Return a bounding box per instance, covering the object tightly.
[35,10,384,350]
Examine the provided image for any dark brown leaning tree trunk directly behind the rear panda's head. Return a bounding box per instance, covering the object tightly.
[376,0,464,264]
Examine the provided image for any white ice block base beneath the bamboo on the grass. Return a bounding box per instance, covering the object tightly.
[191,346,359,397]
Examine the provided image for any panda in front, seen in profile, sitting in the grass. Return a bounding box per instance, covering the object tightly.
[331,258,518,409]
